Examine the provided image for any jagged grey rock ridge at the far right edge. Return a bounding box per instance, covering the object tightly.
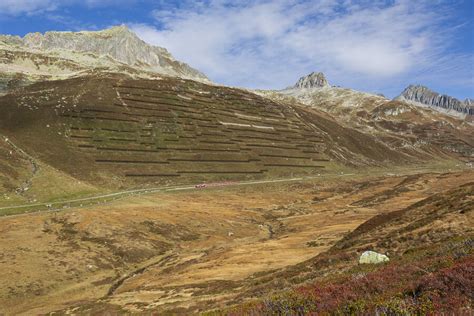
[396,85,474,115]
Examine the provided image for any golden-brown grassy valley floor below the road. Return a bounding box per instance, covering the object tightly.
[0,170,474,314]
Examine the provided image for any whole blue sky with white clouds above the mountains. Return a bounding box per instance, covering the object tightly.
[0,0,474,99]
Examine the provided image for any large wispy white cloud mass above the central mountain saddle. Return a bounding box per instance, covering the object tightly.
[130,0,468,95]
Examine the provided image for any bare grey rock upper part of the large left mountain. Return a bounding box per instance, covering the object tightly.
[0,25,208,81]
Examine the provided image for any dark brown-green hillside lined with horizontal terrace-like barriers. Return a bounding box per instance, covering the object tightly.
[0,75,408,188]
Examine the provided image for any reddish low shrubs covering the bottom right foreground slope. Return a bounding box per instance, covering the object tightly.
[226,241,474,315]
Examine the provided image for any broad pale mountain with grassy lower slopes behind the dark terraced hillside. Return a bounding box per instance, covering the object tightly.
[0,25,209,90]
